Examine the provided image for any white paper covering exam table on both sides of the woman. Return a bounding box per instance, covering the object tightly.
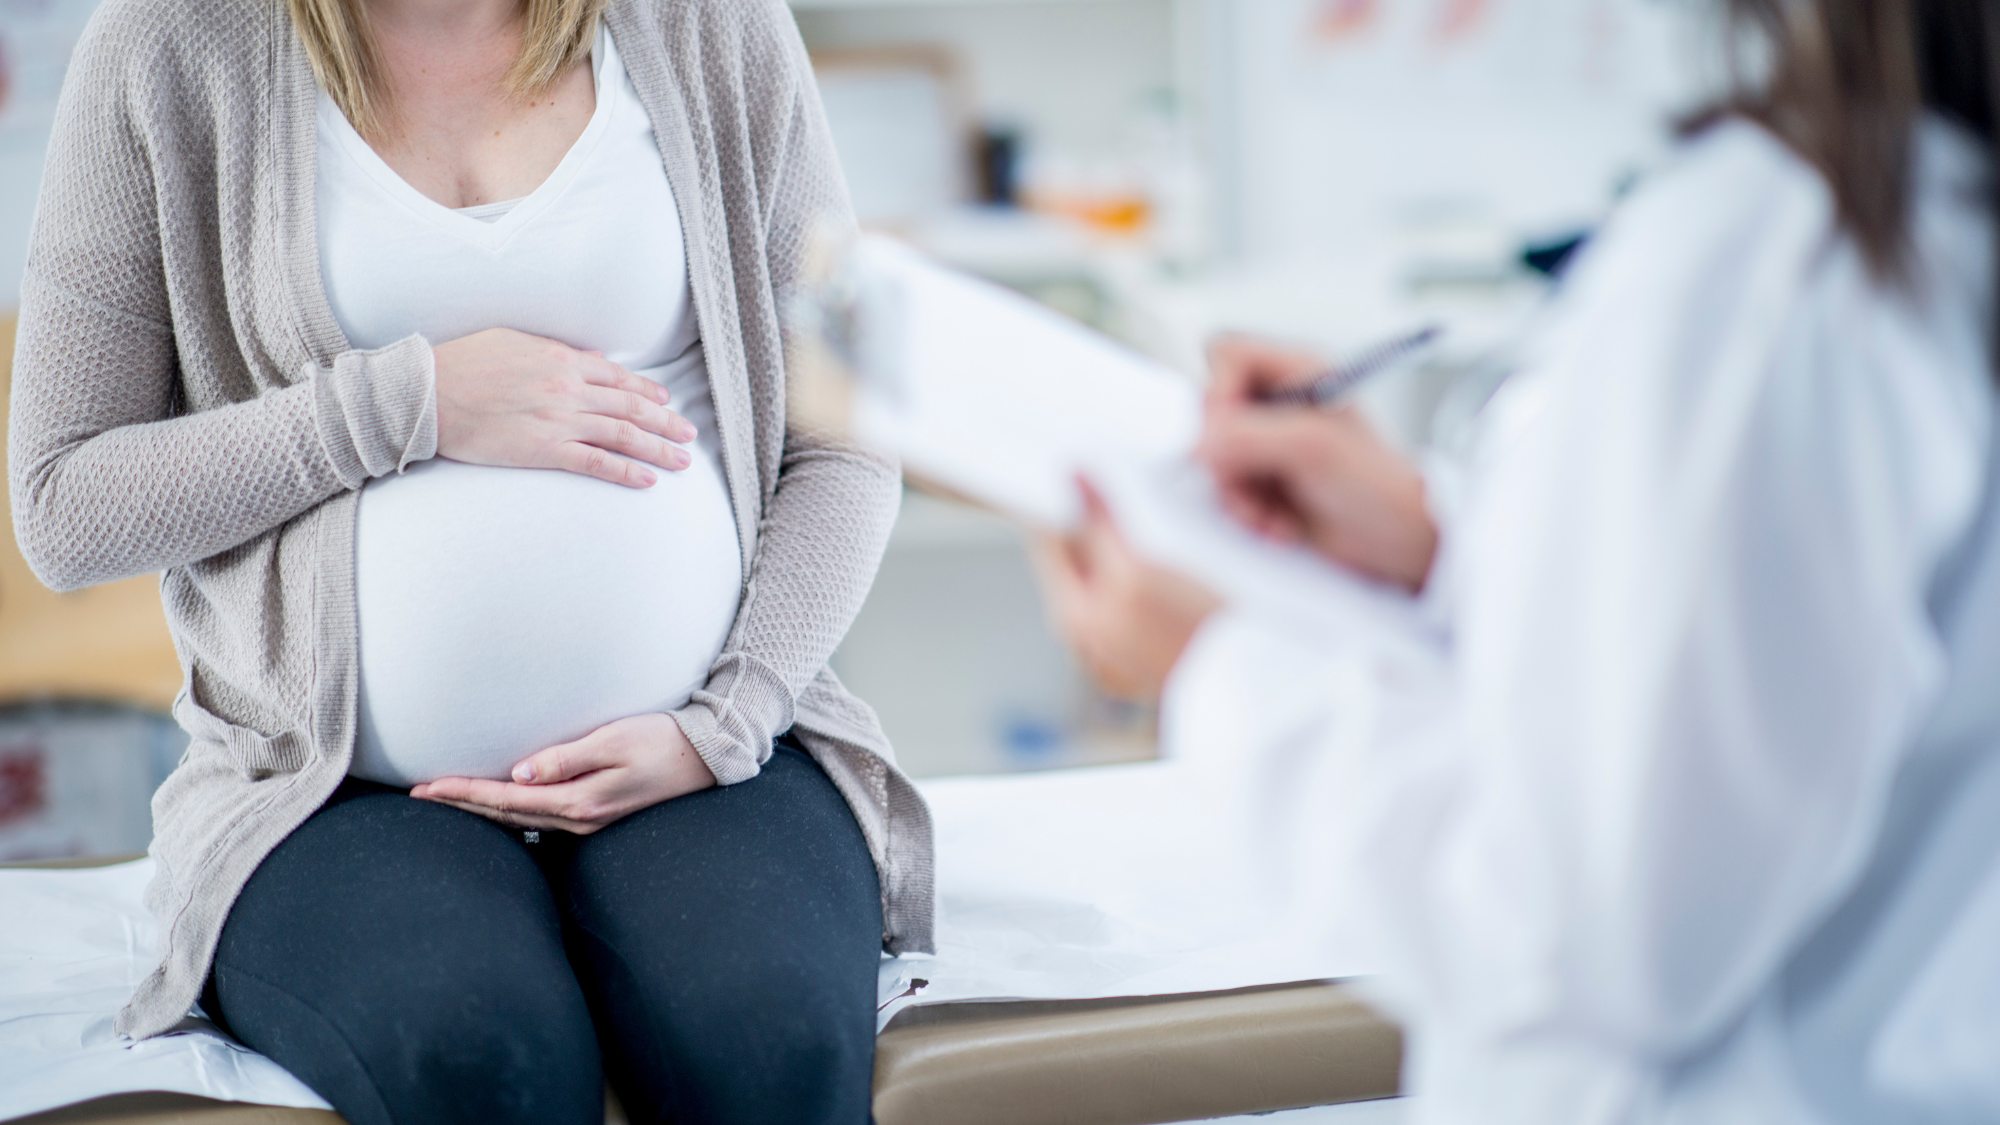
[0,763,1364,1119]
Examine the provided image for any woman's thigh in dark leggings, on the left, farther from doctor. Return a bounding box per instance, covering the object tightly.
[208,779,604,1125]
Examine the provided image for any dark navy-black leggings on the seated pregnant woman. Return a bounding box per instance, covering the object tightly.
[204,737,882,1125]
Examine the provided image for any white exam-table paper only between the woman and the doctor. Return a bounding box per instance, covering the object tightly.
[880,761,1366,1025]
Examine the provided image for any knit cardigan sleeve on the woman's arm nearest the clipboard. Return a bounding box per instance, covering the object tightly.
[674,0,902,785]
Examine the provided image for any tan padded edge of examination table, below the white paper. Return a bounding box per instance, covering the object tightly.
[3,820,1402,1125]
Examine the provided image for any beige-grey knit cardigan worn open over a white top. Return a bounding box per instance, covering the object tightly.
[8,0,932,1037]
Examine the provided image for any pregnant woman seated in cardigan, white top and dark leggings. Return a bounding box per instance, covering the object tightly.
[10,0,932,1125]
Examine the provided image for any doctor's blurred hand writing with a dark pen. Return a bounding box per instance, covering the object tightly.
[1200,336,1438,593]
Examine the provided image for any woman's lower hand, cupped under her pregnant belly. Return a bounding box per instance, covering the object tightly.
[410,715,716,835]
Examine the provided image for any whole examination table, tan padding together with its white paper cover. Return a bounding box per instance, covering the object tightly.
[0,684,1402,1125]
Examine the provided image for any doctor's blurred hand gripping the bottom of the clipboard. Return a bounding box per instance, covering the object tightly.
[1034,482,1222,699]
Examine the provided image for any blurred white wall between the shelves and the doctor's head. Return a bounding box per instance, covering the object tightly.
[1210,0,1714,262]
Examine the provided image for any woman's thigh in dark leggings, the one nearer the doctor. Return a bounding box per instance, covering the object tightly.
[550,739,882,1125]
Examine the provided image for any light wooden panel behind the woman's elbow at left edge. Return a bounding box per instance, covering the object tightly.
[0,316,180,711]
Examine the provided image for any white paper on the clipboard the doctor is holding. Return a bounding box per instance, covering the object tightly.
[812,236,1414,637]
